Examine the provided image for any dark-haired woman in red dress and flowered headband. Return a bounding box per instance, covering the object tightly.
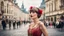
[28,6,48,36]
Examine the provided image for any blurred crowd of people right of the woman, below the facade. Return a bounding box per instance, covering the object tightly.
[44,15,64,29]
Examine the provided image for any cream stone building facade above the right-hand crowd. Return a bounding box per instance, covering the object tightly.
[45,0,64,21]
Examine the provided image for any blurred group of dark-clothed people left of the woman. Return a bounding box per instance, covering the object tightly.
[1,19,21,30]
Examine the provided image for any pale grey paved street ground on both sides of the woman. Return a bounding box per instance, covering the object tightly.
[0,24,64,36]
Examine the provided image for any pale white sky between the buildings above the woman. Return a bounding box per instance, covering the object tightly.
[16,0,42,10]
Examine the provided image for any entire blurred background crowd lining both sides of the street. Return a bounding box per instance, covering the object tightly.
[1,16,64,30]
